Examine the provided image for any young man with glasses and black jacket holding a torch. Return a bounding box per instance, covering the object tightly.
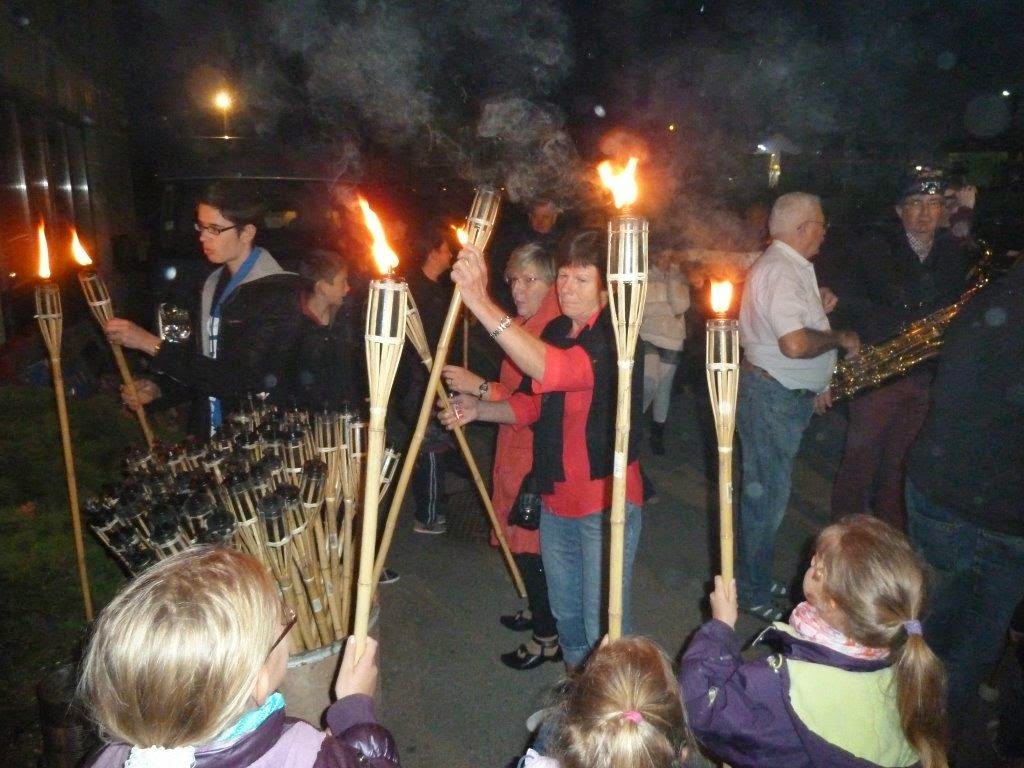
[104,177,302,436]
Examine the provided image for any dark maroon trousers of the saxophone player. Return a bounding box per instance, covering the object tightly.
[831,373,930,530]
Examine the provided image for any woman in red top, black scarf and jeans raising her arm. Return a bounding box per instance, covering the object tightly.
[440,230,643,670]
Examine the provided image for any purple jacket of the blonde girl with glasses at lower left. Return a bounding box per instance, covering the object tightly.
[85,693,400,768]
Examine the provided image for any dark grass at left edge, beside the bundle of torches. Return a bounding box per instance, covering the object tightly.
[0,387,180,767]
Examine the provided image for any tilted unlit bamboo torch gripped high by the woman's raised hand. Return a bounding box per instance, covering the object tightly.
[378,186,505,585]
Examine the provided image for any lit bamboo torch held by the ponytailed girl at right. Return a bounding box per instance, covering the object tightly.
[707,282,739,583]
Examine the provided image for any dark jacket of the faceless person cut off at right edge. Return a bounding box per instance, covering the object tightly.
[907,261,1024,537]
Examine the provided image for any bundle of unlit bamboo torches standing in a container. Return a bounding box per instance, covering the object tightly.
[85,403,399,652]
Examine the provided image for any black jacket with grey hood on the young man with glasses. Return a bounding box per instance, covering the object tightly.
[151,251,302,436]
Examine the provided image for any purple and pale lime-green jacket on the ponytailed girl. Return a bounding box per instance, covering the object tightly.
[679,621,920,768]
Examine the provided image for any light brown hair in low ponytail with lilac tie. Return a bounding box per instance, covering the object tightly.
[816,515,947,768]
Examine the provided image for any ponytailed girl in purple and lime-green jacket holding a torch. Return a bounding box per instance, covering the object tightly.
[680,515,947,768]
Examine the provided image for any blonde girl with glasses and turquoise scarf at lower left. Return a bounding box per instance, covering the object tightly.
[79,547,398,768]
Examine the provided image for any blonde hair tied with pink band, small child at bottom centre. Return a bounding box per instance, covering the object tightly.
[552,637,691,768]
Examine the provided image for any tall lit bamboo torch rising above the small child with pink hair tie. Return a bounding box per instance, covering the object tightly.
[598,158,647,640]
